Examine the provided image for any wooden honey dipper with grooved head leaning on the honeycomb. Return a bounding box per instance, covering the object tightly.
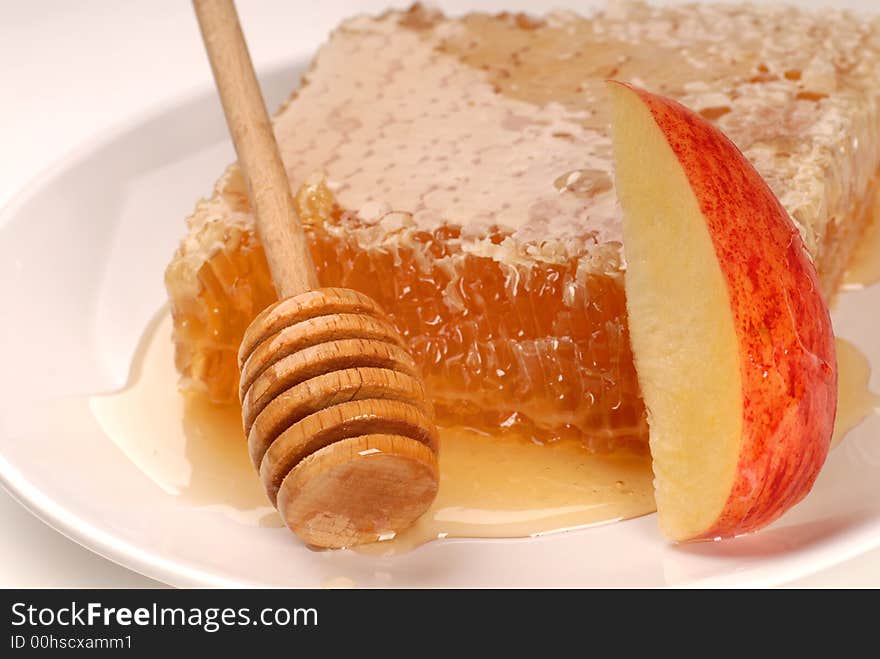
[193,0,438,547]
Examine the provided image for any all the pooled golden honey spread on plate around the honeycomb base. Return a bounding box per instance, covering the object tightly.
[89,310,880,555]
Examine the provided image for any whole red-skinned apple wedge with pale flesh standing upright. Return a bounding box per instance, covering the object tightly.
[609,82,837,541]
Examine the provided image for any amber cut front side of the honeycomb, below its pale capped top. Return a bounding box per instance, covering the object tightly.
[166,173,645,448]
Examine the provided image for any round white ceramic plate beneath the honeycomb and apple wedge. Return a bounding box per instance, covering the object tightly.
[0,49,880,587]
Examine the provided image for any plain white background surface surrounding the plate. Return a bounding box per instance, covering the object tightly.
[0,0,880,587]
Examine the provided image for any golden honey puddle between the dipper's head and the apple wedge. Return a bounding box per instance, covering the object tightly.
[356,428,656,556]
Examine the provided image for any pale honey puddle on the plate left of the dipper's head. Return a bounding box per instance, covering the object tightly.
[88,310,283,526]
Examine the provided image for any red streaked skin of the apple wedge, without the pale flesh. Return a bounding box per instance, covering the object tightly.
[627,85,837,539]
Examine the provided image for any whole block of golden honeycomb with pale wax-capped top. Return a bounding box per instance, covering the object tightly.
[166,2,880,450]
